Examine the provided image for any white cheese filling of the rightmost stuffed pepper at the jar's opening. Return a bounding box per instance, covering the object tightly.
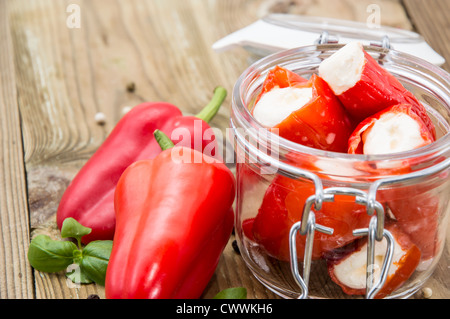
[363,113,425,155]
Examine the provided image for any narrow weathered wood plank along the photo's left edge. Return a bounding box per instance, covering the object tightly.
[0,1,34,299]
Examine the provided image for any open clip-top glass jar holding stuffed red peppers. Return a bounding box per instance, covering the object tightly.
[230,44,450,298]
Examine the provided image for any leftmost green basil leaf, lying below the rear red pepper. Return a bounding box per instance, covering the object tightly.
[28,235,78,272]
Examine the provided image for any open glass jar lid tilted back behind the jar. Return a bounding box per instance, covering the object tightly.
[212,14,445,66]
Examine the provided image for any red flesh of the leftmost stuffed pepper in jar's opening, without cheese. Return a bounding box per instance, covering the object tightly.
[253,67,354,153]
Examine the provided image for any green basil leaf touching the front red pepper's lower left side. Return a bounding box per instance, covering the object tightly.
[80,240,113,286]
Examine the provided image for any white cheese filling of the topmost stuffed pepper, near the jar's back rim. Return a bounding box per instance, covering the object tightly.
[319,42,365,95]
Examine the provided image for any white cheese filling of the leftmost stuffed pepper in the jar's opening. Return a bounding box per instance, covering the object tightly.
[253,87,312,127]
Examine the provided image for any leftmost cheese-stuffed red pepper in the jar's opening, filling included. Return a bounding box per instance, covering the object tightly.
[253,66,354,152]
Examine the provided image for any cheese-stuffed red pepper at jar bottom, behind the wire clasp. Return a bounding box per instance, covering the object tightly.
[328,224,420,299]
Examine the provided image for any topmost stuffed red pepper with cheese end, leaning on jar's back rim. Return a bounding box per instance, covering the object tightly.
[319,42,436,138]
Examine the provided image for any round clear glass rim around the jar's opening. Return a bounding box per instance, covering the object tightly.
[232,44,450,168]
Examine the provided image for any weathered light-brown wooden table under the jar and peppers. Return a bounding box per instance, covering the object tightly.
[0,0,450,299]
